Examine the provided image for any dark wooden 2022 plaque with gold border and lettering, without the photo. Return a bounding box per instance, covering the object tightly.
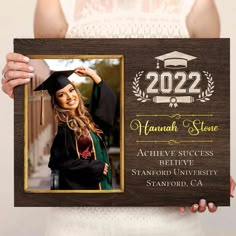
[14,39,230,206]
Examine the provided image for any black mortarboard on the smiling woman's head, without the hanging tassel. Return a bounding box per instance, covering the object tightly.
[34,70,75,96]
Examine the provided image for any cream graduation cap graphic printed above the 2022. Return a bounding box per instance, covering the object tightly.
[155,51,197,69]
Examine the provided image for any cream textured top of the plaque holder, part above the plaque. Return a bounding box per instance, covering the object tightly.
[66,0,194,38]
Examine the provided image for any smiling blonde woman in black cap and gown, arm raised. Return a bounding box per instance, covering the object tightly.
[34,67,116,190]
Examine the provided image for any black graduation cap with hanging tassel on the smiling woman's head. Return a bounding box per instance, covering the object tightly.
[34,70,75,125]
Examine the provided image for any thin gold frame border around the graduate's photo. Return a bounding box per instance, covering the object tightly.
[24,54,124,193]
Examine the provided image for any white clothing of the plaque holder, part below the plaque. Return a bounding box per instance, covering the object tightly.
[46,206,203,236]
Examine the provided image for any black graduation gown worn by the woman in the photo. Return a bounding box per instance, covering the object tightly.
[48,81,116,190]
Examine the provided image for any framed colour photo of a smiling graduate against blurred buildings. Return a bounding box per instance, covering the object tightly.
[24,58,122,193]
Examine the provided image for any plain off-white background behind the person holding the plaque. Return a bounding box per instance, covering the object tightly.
[0,0,236,236]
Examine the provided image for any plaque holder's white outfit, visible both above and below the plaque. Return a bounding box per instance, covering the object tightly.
[46,0,203,236]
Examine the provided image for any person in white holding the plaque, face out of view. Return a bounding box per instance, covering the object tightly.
[2,0,235,236]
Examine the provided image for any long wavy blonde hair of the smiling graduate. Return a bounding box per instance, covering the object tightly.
[51,83,102,138]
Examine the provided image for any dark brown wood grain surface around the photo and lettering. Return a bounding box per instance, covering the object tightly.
[14,39,230,206]
